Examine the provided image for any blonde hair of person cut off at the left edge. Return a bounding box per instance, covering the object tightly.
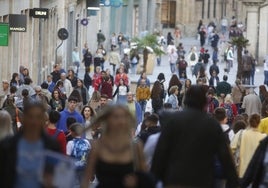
[0,110,13,140]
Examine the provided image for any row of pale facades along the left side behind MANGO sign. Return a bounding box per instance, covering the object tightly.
[0,0,160,83]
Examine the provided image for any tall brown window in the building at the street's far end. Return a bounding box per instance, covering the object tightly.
[161,0,176,28]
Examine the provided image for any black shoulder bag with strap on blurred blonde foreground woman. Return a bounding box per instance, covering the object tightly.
[132,141,157,188]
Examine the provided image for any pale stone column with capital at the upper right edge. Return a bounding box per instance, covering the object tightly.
[243,0,265,57]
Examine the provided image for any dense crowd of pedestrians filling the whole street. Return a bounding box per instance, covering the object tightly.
[0,24,268,188]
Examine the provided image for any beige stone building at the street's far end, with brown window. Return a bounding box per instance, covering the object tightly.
[159,0,238,36]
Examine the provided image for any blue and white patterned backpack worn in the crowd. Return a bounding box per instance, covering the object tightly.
[71,138,91,169]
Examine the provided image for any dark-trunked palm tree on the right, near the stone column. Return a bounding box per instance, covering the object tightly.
[229,36,249,79]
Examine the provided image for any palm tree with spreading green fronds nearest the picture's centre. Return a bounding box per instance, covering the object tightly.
[131,34,164,72]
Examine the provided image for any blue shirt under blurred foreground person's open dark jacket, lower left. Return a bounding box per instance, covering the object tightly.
[15,138,44,188]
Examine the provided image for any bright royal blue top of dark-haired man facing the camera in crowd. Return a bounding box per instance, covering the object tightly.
[57,110,84,132]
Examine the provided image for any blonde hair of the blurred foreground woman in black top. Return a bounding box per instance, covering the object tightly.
[89,105,136,135]
